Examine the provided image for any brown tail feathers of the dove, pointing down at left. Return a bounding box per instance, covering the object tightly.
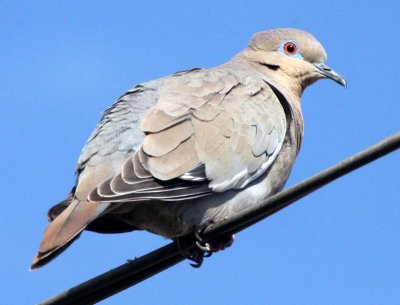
[31,199,109,269]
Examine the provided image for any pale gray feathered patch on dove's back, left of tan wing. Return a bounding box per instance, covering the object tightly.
[75,81,158,199]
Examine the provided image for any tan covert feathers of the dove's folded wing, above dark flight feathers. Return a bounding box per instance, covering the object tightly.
[142,68,286,191]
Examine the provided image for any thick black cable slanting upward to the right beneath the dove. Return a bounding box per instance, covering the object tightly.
[38,132,400,305]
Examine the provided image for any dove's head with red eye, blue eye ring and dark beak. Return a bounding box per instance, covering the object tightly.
[244,29,346,95]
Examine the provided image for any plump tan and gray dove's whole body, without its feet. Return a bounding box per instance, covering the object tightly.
[32,29,345,268]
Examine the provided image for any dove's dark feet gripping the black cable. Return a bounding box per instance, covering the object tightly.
[177,231,235,268]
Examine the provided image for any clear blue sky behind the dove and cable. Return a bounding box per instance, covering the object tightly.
[0,0,400,305]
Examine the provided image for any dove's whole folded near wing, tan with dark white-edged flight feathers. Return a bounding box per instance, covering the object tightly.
[89,68,286,202]
